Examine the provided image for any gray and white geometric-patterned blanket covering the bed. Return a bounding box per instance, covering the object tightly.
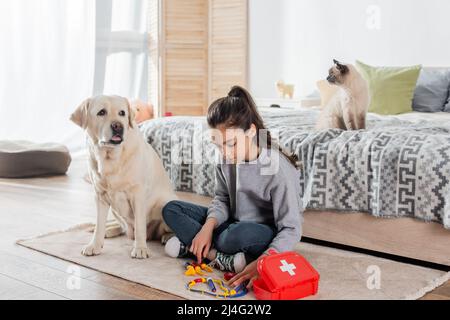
[140,108,450,229]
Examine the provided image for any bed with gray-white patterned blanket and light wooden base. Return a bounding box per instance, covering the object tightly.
[140,107,450,266]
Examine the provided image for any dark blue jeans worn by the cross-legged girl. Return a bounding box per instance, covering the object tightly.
[162,200,276,263]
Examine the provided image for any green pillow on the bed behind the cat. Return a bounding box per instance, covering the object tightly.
[356,61,422,114]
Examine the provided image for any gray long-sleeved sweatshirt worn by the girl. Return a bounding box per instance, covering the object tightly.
[208,148,303,252]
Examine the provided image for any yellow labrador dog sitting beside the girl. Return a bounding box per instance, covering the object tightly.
[70,96,177,259]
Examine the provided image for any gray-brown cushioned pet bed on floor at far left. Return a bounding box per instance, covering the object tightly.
[0,140,72,178]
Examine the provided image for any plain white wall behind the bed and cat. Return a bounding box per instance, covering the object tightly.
[249,0,450,98]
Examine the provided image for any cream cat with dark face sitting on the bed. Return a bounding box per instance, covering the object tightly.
[316,60,370,130]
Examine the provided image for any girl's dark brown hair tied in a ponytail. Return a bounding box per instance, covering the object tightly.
[206,86,299,168]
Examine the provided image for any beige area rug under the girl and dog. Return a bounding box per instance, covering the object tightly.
[17,225,450,300]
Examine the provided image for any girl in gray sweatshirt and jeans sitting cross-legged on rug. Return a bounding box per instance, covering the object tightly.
[163,86,303,287]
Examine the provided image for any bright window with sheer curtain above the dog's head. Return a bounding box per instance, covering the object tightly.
[93,0,148,101]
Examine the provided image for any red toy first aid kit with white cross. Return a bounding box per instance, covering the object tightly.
[253,250,320,300]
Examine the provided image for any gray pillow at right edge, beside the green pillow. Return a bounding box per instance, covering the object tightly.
[413,68,450,112]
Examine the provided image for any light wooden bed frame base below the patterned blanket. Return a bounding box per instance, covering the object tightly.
[177,192,450,267]
